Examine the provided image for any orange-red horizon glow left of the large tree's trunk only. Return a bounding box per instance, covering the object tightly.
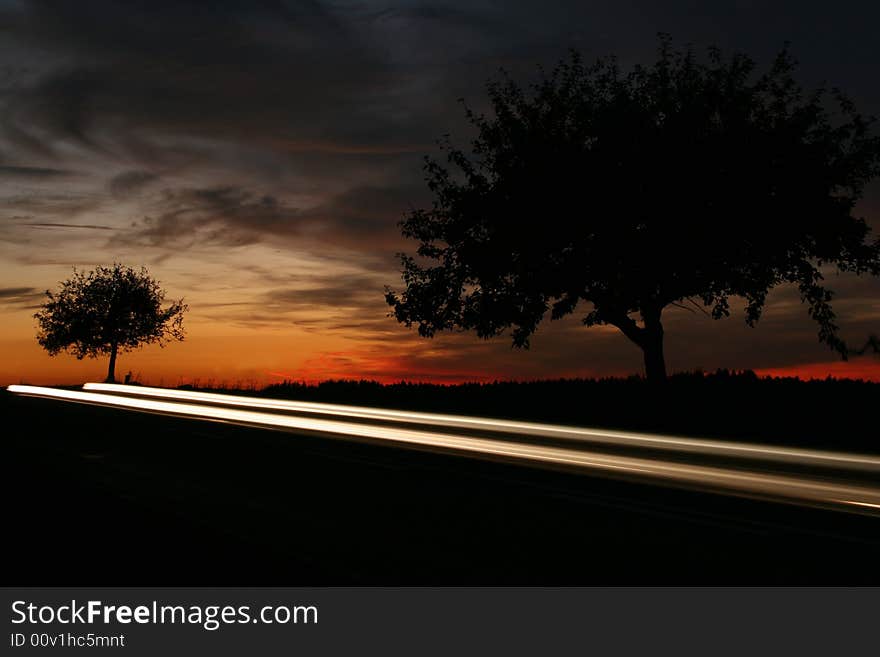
[0,334,591,388]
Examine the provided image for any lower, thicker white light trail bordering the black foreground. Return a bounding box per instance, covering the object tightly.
[8,385,880,514]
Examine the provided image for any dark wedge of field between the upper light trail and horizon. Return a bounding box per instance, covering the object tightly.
[251,370,880,453]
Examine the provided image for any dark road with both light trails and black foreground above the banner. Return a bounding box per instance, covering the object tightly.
[4,385,880,584]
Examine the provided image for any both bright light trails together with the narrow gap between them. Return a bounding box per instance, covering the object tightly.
[9,383,880,515]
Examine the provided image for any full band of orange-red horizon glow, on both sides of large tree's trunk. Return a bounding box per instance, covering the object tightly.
[0,325,880,388]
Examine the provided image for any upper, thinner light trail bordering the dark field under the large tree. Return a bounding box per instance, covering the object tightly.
[83,383,880,474]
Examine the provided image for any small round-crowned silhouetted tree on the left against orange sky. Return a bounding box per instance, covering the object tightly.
[34,264,187,383]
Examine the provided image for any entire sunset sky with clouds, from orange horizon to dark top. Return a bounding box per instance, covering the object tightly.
[0,0,880,385]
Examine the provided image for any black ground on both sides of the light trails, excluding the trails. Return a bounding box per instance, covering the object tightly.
[0,375,880,586]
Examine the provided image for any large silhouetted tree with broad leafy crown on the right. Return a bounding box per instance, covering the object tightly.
[386,37,880,380]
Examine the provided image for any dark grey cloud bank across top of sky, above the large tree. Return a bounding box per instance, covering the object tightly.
[0,0,880,164]
